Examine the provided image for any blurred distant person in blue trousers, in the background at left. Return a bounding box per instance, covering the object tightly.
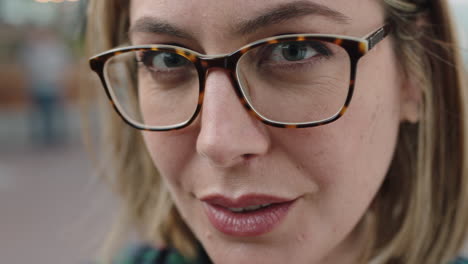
[19,26,70,145]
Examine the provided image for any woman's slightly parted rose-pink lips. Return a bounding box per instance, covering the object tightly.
[201,195,296,237]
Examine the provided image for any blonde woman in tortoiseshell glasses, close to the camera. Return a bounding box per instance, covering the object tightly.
[88,0,468,264]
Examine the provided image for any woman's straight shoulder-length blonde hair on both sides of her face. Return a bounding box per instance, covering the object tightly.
[86,0,468,264]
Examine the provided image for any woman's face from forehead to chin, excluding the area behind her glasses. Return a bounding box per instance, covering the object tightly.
[130,0,406,264]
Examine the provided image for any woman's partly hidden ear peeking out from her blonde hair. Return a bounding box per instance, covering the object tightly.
[400,76,422,123]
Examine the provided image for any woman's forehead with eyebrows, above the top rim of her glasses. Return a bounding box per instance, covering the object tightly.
[130,0,383,46]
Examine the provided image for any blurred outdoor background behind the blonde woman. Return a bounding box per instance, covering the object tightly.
[0,0,468,264]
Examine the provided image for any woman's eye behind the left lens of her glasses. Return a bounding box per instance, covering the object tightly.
[141,51,189,71]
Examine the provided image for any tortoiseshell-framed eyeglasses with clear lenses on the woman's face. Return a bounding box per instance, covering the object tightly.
[89,24,391,131]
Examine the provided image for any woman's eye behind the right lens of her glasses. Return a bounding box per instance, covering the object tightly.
[264,41,331,63]
